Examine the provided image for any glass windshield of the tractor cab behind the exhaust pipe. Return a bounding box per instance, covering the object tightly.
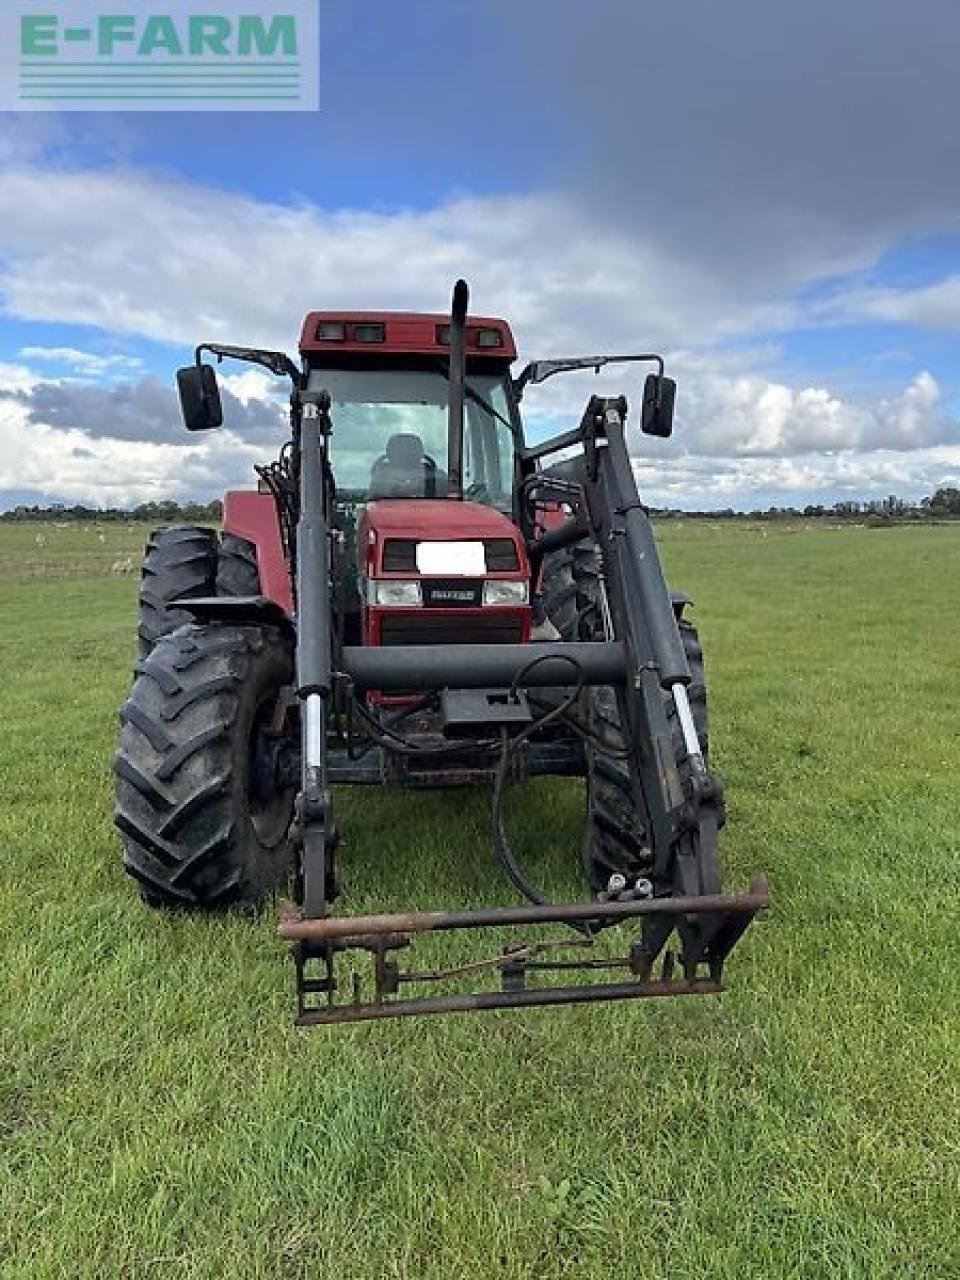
[310,369,513,512]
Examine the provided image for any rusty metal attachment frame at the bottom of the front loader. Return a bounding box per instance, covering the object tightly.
[278,877,769,1027]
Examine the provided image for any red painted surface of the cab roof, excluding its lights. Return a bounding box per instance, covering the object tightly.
[300,311,517,360]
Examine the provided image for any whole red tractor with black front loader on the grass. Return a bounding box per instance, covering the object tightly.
[115,282,767,1023]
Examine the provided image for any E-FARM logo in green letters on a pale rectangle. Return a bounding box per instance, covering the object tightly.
[0,0,319,111]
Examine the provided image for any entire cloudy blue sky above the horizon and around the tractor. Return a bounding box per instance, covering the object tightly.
[0,0,960,509]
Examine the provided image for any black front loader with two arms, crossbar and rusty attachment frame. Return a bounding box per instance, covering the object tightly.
[279,368,768,1024]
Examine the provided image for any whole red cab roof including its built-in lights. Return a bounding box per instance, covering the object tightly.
[300,311,517,364]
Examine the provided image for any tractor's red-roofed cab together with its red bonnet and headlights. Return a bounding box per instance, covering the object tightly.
[300,311,531,645]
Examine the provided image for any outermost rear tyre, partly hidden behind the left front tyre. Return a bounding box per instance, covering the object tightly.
[137,525,219,658]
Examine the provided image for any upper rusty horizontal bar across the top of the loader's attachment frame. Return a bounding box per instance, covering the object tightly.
[278,876,769,942]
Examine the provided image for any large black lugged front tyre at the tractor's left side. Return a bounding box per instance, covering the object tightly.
[114,625,293,908]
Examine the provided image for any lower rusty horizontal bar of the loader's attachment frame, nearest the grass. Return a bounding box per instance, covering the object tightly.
[297,978,723,1027]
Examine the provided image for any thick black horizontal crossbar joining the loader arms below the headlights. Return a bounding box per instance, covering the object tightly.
[343,641,627,694]
